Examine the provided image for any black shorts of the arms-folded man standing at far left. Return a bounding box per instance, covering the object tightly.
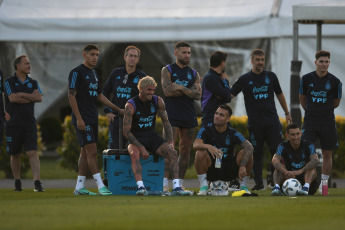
[6,125,37,155]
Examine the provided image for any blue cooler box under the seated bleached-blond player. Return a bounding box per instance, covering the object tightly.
[103,149,164,195]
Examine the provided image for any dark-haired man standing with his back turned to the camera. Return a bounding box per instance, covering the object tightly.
[201,51,231,126]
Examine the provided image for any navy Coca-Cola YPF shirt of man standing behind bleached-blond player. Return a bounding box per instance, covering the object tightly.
[103,67,146,115]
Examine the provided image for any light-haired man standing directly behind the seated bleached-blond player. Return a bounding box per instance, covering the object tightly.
[103,46,146,149]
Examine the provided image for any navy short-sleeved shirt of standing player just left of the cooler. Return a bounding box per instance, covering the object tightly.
[68,64,102,125]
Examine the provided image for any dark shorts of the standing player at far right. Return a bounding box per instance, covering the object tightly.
[301,125,338,150]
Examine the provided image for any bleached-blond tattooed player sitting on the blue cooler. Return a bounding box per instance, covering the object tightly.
[123,76,189,195]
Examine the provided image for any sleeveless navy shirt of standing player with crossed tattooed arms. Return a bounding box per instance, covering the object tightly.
[165,63,198,128]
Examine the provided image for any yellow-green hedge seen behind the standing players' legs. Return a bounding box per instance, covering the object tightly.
[58,116,345,176]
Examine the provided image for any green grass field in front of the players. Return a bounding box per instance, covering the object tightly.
[0,189,345,230]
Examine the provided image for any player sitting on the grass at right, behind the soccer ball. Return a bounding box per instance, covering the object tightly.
[271,124,320,196]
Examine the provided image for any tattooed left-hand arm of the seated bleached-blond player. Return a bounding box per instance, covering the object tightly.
[123,103,149,159]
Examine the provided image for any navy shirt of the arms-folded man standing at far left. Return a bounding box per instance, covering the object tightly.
[4,73,42,126]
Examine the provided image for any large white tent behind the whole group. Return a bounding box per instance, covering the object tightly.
[0,0,345,120]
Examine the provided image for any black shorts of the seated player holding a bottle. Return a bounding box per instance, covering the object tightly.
[207,153,239,182]
